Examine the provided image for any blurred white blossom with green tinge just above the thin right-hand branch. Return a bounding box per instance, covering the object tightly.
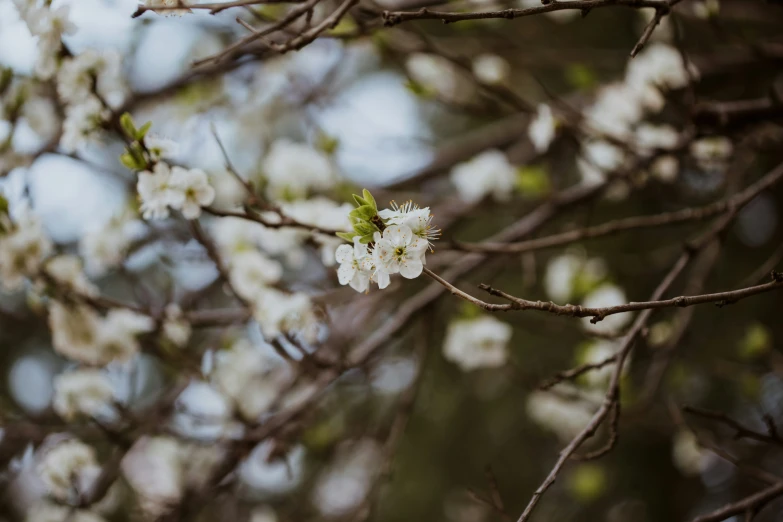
[544,249,606,303]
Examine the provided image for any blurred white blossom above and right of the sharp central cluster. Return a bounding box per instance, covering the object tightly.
[451,150,516,203]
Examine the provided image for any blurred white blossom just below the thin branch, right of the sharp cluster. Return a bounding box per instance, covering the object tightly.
[443,315,512,372]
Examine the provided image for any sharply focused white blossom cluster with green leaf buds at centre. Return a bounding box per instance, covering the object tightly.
[335,189,440,292]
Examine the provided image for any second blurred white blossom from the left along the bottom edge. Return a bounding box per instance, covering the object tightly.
[121,436,185,517]
